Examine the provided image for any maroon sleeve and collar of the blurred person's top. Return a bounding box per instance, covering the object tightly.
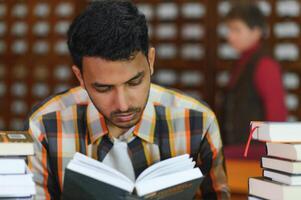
[228,44,287,121]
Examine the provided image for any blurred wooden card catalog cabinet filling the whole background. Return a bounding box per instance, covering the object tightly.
[0,0,301,129]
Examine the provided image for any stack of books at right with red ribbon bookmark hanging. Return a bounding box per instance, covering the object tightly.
[249,122,301,200]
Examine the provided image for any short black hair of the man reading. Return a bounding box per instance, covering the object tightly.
[67,0,149,70]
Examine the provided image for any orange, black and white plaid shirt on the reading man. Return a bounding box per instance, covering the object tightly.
[28,84,230,199]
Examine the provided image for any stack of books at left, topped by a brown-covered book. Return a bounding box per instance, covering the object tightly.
[0,131,36,199]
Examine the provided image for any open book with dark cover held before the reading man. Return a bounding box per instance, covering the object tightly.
[63,153,203,200]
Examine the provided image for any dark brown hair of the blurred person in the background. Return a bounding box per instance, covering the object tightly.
[225,0,267,36]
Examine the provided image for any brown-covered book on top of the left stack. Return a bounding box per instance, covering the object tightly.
[0,131,34,156]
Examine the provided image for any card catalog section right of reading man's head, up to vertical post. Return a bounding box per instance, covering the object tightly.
[135,0,207,99]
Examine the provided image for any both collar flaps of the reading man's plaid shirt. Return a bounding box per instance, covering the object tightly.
[87,98,156,144]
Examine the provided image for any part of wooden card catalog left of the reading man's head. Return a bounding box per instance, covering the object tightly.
[0,0,86,130]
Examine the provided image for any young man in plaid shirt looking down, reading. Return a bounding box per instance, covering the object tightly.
[29,0,229,199]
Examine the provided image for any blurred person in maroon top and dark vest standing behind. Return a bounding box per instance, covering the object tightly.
[222,1,287,145]
